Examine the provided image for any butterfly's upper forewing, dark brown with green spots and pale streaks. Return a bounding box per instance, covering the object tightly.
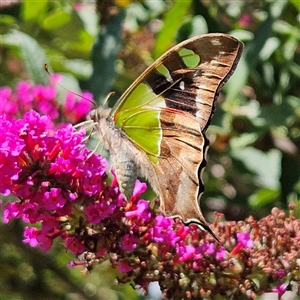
[111,34,243,130]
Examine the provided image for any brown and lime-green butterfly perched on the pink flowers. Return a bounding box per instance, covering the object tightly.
[97,33,243,240]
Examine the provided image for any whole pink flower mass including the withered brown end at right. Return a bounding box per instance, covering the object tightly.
[0,84,300,299]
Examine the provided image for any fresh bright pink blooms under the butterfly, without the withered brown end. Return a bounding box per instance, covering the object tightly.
[0,111,222,268]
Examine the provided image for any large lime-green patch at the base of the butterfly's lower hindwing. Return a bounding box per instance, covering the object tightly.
[115,106,162,163]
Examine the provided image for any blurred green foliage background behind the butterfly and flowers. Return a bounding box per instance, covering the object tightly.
[0,0,300,299]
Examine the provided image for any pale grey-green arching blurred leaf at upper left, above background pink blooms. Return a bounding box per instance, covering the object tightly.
[3,30,48,84]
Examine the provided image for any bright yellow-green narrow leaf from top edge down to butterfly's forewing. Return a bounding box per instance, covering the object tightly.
[153,0,191,59]
